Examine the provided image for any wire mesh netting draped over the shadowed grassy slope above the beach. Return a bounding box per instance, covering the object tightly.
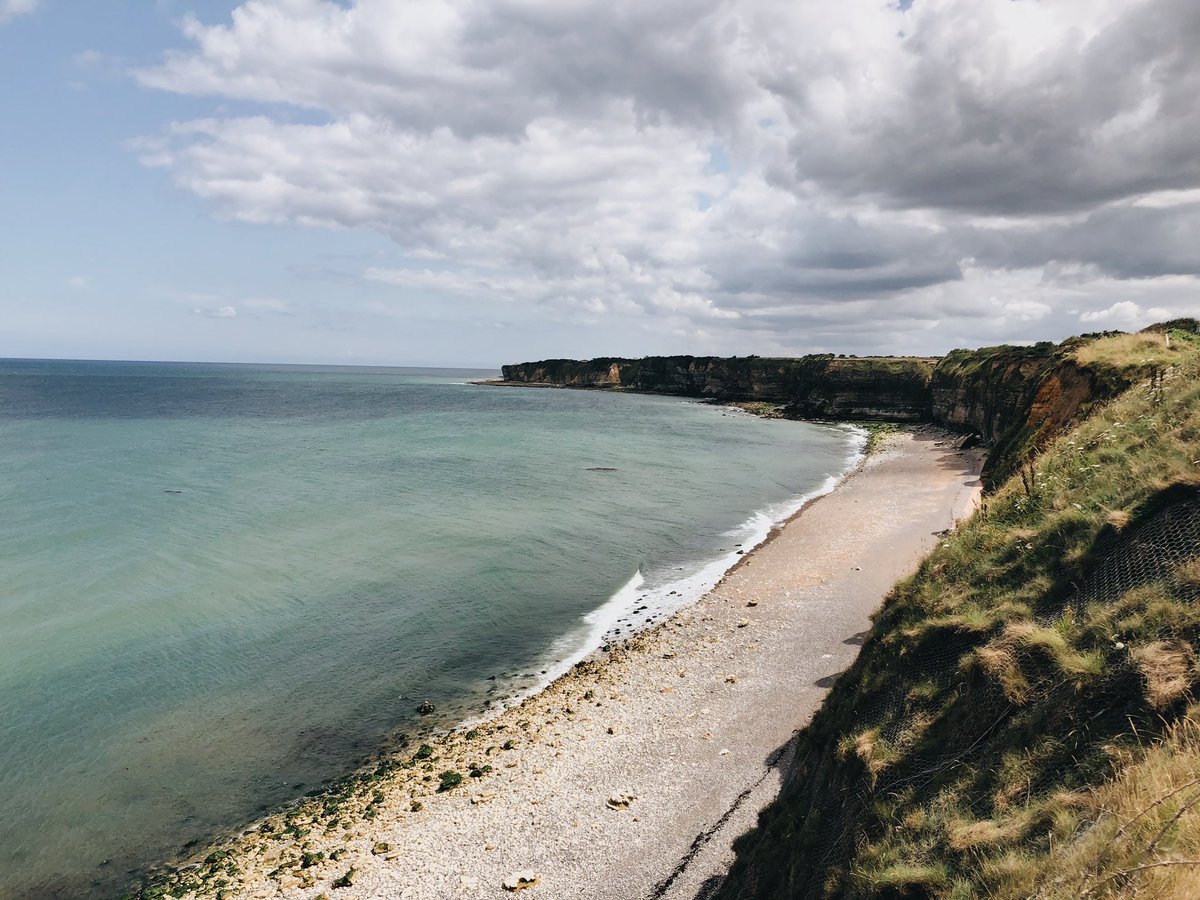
[720,486,1200,899]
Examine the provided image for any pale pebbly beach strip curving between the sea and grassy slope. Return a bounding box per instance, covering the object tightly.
[166,431,980,900]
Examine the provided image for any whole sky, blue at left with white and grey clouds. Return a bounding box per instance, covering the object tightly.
[0,0,1200,367]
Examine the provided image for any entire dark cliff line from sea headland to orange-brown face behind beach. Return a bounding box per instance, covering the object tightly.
[503,319,1200,488]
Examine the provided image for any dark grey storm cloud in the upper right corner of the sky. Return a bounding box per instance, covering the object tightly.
[780,0,1200,215]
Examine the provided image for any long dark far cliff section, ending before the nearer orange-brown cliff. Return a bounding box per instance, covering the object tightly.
[503,355,934,421]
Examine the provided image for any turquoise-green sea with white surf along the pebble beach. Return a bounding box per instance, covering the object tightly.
[0,360,859,896]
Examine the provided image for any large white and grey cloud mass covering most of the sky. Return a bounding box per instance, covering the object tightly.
[137,0,1200,352]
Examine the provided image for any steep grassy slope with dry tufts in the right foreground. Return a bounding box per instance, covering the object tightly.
[719,332,1200,898]
